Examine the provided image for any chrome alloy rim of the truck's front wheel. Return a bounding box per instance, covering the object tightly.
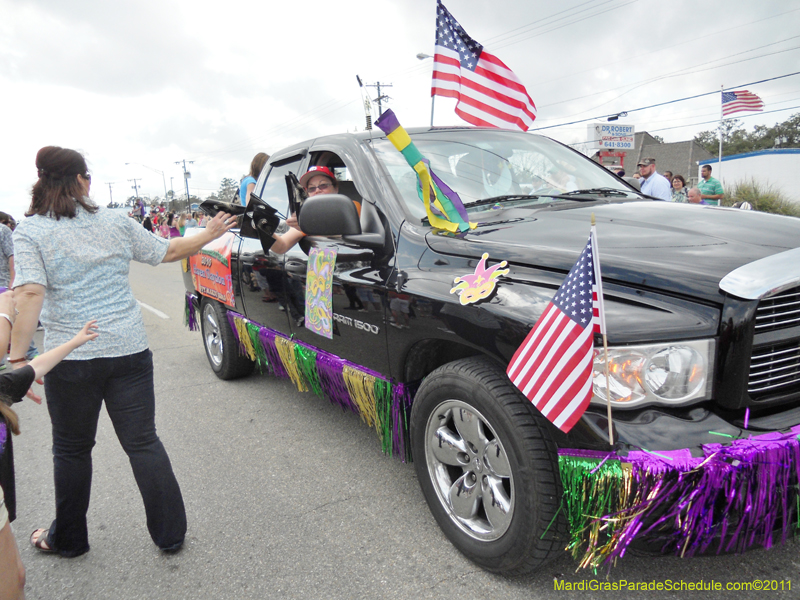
[425,400,514,541]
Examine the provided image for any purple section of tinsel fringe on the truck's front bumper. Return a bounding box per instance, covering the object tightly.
[559,426,800,564]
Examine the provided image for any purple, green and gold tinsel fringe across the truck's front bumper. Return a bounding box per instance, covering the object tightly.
[559,426,800,568]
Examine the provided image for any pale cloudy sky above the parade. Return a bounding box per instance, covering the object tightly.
[0,0,800,218]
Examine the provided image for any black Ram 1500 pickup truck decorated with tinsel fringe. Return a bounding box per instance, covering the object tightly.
[184,128,800,573]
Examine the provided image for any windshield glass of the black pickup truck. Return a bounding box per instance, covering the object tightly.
[372,129,636,218]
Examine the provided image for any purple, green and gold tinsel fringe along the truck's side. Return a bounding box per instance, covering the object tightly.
[228,311,411,462]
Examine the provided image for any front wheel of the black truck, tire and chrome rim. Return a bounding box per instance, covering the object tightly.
[411,358,566,575]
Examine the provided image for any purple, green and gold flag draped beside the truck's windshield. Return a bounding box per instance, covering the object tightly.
[375,109,477,233]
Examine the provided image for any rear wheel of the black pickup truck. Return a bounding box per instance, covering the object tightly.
[200,298,255,380]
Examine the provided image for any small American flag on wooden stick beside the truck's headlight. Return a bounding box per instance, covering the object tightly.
[506,226,606,433]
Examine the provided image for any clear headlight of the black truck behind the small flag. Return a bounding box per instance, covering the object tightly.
[592,340,714,408]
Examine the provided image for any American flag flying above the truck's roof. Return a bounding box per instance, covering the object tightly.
[431,0,536,131]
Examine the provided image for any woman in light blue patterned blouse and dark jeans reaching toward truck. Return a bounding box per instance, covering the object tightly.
[9,146,236,557]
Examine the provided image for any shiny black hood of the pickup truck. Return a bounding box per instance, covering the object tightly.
[427,201,800,302]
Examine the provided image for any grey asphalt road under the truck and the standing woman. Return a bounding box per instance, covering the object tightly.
[7,263,800,600]
